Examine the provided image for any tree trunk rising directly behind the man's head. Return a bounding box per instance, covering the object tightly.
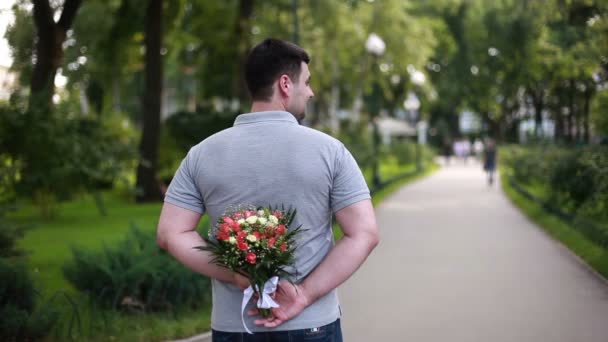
[232,0,255,108]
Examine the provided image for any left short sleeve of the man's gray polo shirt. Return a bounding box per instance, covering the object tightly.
[165,151,205,215]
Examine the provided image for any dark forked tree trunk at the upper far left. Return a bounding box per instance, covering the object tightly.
[30,0,81,108]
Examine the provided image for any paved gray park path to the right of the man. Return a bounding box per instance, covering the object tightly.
[339,161,608,342]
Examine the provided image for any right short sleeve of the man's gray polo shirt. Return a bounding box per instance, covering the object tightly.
[330,145,371,212]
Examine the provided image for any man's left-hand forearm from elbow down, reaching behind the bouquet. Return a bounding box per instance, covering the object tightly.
[163,231,234,283]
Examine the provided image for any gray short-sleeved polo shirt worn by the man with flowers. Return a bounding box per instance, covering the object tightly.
[165,111,370,332]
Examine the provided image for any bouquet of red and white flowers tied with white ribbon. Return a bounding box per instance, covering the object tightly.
[195,207,301,330]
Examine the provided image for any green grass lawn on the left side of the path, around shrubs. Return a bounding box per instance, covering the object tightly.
[10,159,436,341]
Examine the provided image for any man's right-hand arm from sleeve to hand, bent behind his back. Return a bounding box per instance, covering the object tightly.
[251,200,380,328]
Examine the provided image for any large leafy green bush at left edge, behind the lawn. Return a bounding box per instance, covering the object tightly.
[0,105,135,217]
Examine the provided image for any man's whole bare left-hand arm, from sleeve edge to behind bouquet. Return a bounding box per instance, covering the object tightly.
[156,202,249,289]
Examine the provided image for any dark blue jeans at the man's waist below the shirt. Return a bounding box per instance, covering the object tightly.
[211,319,342,342]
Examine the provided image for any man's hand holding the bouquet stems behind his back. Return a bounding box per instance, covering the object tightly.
[249,280,311,328]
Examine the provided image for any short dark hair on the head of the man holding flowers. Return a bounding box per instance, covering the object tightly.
[245,38,310,101]
